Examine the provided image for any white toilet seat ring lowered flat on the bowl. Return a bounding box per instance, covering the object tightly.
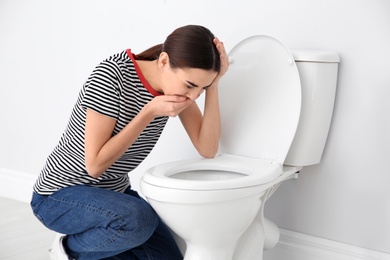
[143,154,283,191]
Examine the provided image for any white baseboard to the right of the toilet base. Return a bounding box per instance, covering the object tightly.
[264,229,390,260]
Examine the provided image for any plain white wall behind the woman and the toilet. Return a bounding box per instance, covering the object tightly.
[0,0,390,253]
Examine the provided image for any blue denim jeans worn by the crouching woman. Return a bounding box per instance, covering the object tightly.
[31,186,183,260]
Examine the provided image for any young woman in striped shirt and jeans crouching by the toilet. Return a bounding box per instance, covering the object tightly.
[31,25,229,260]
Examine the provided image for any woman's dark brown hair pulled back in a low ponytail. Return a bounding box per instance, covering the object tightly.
[137,25,221,72]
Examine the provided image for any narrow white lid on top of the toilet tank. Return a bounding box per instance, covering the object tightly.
[291,50,340,63]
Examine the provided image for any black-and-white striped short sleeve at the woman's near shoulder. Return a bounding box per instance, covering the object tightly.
[81,60,120,119]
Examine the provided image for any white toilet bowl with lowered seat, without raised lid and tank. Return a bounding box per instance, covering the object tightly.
[141,154,299,260]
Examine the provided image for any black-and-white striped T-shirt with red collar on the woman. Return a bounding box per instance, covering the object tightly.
[33,50,168,195]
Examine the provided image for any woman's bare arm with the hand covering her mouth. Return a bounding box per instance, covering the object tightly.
[84,96,192,178]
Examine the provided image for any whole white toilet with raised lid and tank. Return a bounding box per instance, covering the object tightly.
[141,35,340,260]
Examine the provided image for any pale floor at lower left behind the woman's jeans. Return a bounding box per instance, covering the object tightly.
[0,197,55,260]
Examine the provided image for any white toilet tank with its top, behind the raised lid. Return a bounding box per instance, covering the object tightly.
[284,50,340,166]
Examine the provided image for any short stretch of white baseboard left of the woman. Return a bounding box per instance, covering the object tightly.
[0,168,37,203]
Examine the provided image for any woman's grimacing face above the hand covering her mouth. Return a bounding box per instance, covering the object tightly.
[160,52,217,100]
